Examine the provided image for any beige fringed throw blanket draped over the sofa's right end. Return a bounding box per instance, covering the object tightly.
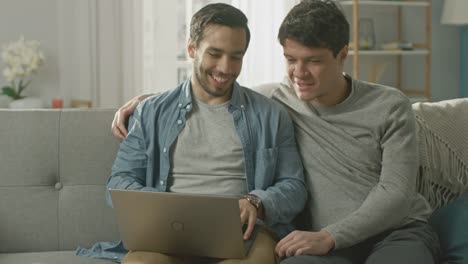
[413,98,468,209]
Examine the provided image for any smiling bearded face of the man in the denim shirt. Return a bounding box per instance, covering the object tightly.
[188,25,247,104]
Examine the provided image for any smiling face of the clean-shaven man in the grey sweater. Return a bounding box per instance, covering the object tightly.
[283,39,349,106]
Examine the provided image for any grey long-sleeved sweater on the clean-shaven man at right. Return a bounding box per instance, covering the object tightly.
[257,76,430,249]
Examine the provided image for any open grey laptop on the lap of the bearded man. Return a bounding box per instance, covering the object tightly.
[110,190,251,259]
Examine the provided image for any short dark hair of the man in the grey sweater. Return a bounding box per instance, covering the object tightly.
[278,0,349,57]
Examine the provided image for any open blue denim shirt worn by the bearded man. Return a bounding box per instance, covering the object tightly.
[77,80,307,262]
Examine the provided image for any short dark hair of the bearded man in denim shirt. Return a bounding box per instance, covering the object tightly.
[190,3,250,50]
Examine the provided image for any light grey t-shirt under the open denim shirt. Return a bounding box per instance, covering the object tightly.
[169,97,247,196]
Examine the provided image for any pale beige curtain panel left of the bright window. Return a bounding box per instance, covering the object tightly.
[57,0,142,108]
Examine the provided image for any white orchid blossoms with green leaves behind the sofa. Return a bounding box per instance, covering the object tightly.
[1,37,45,100]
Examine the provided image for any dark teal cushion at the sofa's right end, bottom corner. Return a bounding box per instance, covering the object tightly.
[430,194,468,264]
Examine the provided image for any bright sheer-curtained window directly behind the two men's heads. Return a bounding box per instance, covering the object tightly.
[141,0,297,92]
